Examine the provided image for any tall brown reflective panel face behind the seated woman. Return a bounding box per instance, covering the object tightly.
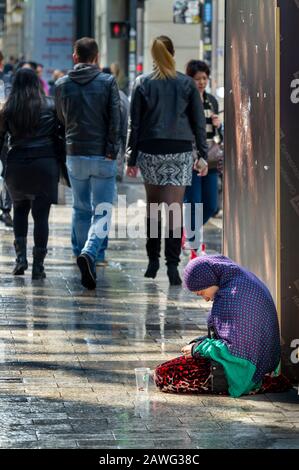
[224,0,277,299]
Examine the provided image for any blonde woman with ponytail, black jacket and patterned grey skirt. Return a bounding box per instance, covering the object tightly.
[127,36,207,285]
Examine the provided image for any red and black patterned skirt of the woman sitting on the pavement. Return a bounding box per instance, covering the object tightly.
[154,356,291,395]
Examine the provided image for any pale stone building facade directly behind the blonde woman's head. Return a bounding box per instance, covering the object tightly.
[94,0,225,94]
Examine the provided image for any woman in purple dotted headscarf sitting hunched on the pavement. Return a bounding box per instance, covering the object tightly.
[155,256,290,397]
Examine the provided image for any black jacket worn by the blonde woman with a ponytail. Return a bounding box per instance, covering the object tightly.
[127,72,208,166]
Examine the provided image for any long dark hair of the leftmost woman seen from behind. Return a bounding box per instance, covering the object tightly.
[3,69,44,137]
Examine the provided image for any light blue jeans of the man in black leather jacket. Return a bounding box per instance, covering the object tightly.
[67,156,117,261]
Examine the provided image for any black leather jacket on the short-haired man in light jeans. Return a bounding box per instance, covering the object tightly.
[55,64,120,159]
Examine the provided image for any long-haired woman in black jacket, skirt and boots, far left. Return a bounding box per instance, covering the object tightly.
[0,69,59,279]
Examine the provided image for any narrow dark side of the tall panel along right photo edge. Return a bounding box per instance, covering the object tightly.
[278,0,299,381]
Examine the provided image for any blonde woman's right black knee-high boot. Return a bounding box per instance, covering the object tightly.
[165,230,182,286]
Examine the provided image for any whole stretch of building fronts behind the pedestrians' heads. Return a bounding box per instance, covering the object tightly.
[0,0,225,92]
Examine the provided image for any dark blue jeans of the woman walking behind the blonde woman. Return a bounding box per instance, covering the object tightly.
[184,170,219,248]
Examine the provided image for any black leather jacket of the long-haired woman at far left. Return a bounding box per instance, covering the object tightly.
[0,97,59,155]
